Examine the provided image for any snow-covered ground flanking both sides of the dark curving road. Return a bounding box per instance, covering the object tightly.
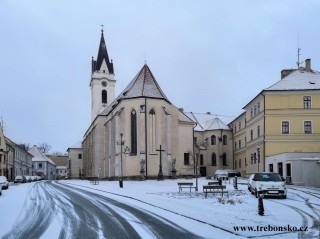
[0,178,320,238]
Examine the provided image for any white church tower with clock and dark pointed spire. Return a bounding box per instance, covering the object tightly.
[90,29,116,121]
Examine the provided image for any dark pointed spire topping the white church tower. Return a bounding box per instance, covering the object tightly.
[92,25,114,74]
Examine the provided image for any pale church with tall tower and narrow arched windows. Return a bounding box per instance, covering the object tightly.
[82,30,196,180]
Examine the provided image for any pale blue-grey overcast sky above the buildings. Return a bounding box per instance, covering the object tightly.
[0,0,320,153]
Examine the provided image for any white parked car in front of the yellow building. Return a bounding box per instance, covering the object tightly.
[250,172,287,198]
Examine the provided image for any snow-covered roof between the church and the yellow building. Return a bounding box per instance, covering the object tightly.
[184,112,230,131]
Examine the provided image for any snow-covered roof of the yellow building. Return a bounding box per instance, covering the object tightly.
[264,68,320,91]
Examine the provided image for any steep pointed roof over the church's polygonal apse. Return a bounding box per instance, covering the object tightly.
[100,64,171,115]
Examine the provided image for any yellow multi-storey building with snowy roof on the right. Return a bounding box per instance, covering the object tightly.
[230,59,320,186]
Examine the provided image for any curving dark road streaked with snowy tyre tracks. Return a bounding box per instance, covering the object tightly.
[3,181,204,239]
